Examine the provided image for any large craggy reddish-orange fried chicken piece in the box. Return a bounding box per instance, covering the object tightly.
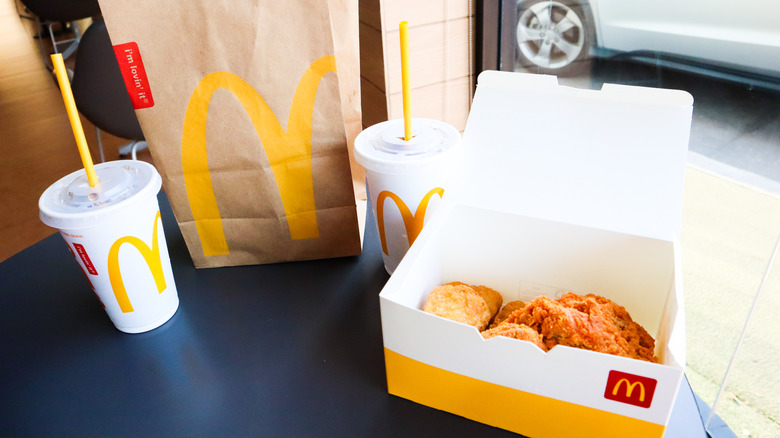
[506,292,657,362]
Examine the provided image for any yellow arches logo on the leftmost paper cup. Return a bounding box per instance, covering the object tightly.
[108,211,168,313]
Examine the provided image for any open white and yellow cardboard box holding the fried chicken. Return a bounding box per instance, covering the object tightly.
[380,72,693,438]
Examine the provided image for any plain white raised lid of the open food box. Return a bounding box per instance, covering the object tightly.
[447,71,693,239]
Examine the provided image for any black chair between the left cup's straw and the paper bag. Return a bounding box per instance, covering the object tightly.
[71,19,147,161]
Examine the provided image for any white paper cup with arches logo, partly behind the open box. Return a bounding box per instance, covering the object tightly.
[355,118,461,274]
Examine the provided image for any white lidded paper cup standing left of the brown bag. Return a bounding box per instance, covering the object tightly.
[38,160,179,333]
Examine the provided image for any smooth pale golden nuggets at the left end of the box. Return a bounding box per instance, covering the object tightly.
[423,282,503,331]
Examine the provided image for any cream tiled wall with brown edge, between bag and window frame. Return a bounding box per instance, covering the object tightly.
[359,0,473,131]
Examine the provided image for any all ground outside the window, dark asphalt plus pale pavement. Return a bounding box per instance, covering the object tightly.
[560,61,780,438]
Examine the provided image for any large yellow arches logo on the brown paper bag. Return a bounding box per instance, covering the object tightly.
[182,55,336,256]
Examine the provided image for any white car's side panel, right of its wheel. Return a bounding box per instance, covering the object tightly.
[591,0,780,74]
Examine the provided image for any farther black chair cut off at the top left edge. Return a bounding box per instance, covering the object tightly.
[22,0,100,69]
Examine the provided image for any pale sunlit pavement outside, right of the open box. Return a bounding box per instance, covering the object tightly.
[681,163,780,437]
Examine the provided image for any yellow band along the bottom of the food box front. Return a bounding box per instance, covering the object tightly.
[385,348,666,438]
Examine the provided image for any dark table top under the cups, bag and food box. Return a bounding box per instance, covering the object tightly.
[0,194,706,438]
